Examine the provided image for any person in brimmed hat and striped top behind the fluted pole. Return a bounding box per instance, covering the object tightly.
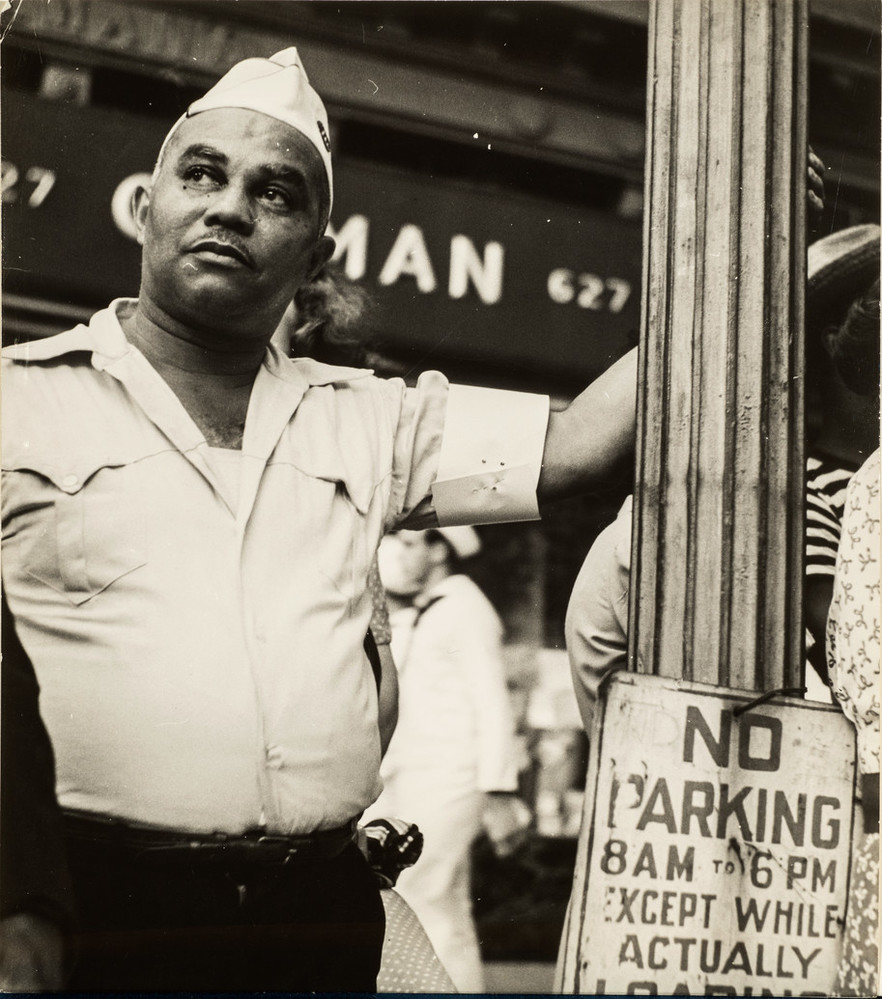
[804,225,880,700]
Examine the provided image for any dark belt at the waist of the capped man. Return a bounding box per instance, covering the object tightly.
[64,811,356,867]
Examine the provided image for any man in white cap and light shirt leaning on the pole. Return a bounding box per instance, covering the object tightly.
[2,49,636,991]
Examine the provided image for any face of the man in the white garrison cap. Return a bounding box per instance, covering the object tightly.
[135,108,334,337]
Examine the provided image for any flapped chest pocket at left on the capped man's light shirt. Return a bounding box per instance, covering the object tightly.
[6,459,147,604]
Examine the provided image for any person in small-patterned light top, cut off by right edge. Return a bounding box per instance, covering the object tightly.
[827,448,882,996]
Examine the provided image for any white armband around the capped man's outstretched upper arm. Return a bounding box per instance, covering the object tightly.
[432,385,549,527]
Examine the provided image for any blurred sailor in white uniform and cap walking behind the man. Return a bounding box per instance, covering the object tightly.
[367,527,529,992]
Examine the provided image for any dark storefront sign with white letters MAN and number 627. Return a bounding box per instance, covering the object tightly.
[3,91,641,381]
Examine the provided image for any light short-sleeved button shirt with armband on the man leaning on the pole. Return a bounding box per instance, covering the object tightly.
[2,300,547,833]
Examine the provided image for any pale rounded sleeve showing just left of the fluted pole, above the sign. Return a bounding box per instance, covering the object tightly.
[565,496,632,738]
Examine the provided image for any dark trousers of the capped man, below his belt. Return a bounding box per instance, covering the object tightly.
[68,840,385,992]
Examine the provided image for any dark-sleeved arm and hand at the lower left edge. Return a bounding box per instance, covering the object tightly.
[0,596,73,992]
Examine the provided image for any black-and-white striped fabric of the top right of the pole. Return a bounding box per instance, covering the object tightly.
[805,452,857,576]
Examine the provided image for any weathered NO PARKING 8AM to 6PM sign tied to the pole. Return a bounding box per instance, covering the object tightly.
[562,674,854,996]
